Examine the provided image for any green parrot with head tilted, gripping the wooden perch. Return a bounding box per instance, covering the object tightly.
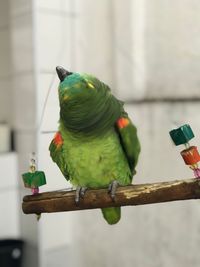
[49,67,140,224]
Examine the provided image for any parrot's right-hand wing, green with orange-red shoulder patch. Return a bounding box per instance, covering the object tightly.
[116,112,140,177]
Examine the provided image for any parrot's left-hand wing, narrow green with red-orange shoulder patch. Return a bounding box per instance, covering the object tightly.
[49,132,69,180]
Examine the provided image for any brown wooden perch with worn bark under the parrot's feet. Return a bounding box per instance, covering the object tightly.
[22,178,200,214]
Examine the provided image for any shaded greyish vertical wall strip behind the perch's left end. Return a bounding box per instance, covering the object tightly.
[9,0,38,267]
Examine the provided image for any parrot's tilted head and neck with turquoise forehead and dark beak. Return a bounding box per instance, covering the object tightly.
[56,67,122,135]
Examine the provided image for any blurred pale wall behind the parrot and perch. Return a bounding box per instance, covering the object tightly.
[0,0,200,267]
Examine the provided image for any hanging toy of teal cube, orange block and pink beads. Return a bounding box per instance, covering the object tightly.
[169,124,200,178]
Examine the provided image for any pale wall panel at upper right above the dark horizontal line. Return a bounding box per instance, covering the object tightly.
[145,0,200,98]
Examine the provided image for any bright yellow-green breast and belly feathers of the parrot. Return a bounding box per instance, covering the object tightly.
[57,122,131,188]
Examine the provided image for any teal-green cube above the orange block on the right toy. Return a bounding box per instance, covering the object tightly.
[169,124,194,146]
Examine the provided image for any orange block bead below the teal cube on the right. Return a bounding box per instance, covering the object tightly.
[181,146,200,165]
